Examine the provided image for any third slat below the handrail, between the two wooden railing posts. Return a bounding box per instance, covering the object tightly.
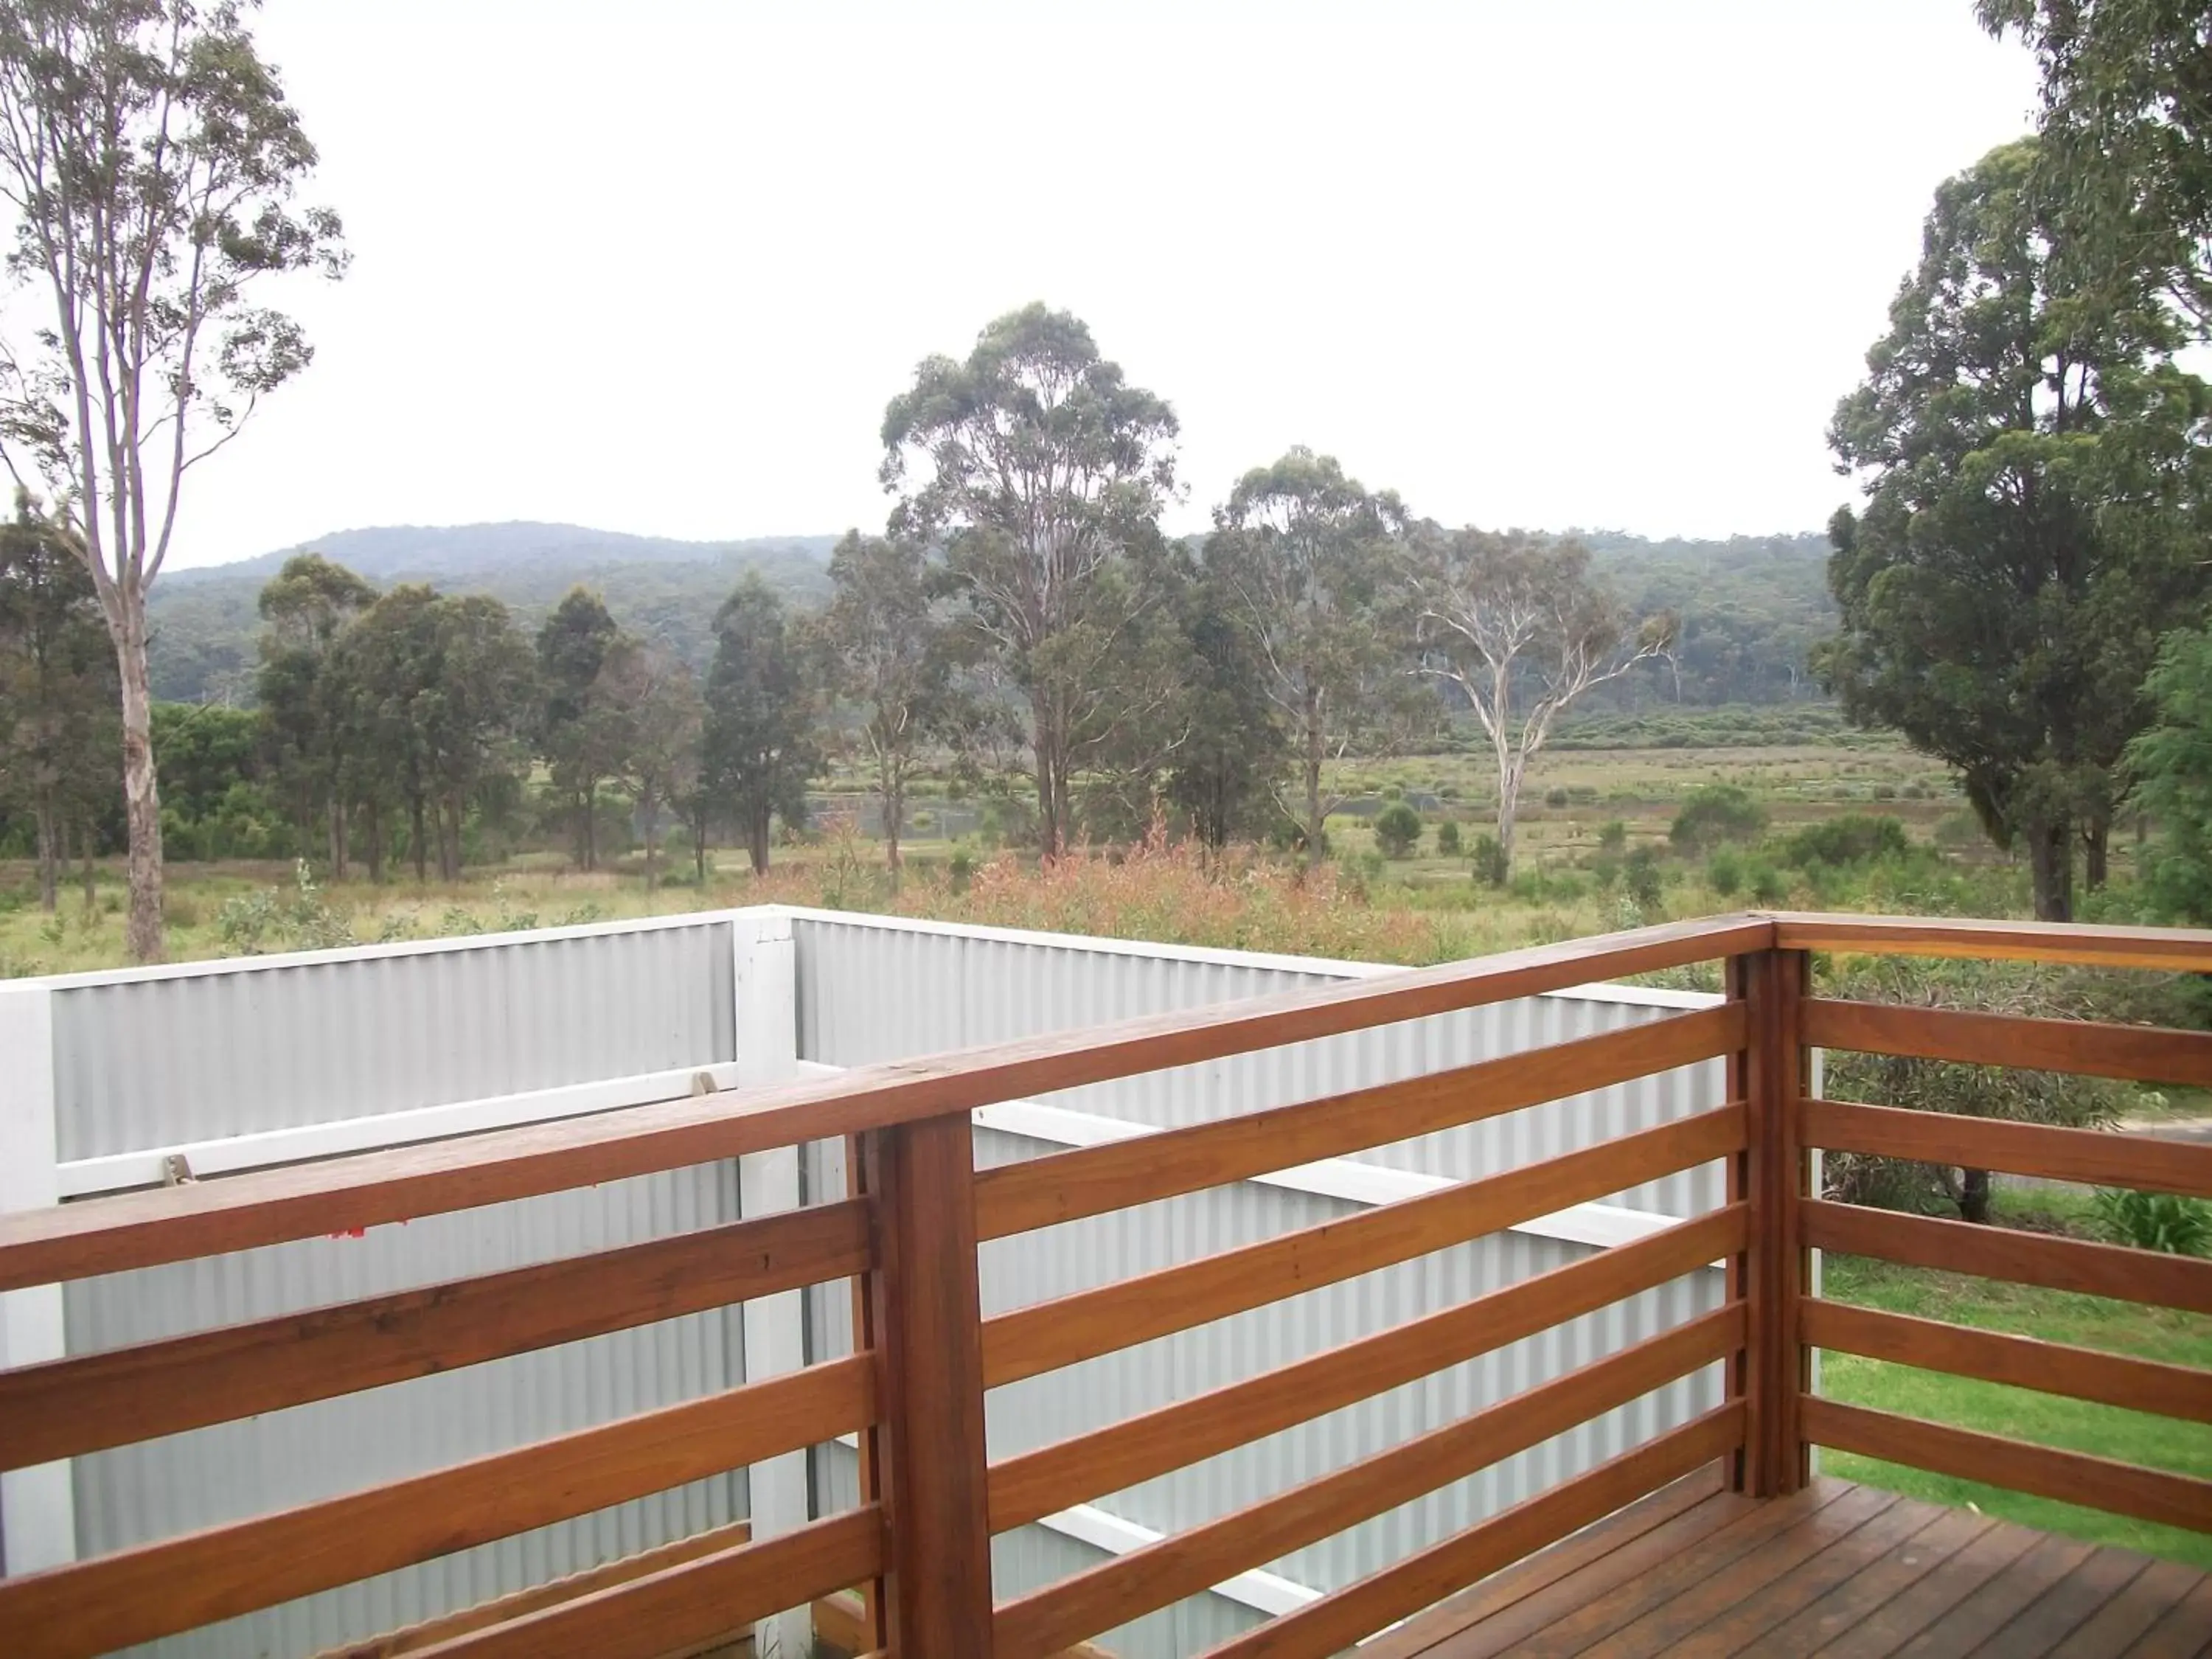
[991,1203,1747,1533]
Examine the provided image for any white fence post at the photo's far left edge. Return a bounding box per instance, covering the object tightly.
[0,984,77,1575]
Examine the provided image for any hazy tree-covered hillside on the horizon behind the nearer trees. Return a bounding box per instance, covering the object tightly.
[153,524,1836,708]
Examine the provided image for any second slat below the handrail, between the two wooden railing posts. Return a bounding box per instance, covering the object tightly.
[982,1104,1745,1387]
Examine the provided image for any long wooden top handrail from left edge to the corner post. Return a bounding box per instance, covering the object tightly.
[0,916,1774,1290]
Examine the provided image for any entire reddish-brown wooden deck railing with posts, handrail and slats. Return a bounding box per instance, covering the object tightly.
[0,916,2212,1659]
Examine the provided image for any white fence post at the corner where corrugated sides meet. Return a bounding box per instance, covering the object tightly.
[730,911,814,1659]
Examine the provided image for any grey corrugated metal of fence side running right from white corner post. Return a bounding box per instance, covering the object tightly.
[792,916,1723,1659]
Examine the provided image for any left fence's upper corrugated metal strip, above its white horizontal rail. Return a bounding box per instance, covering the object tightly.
[53,920,732,1159]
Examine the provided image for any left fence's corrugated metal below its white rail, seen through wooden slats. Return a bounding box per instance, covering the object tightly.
[66,1164,745,1655]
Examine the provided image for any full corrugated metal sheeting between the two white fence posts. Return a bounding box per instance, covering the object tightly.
[30,916,745,1655]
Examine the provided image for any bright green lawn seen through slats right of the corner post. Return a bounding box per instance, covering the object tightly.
[1818,1256,2212,1568]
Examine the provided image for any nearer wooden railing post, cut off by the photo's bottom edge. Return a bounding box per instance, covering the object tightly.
[860,1113,991,1659]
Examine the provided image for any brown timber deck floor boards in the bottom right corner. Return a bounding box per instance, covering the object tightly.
[1360,1469,2212,1659]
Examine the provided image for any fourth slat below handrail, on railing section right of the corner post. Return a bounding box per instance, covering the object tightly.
[1798,1298,2212,1422]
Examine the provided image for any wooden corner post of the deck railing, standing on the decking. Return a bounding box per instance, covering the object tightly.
[1728,951,1812,1498]
